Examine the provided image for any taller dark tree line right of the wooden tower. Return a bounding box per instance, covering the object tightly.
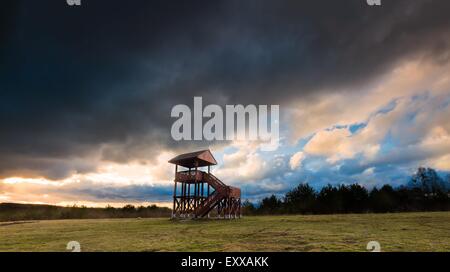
[243,167,450,215]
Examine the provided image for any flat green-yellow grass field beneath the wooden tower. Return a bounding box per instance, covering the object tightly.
[0,212,450,251]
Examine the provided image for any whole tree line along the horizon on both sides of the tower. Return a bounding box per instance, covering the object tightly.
[0,167,450,222]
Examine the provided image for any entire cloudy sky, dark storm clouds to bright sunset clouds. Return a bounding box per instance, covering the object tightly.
[0,0,450,205]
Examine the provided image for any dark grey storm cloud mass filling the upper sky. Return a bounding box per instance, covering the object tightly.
[0,0,450,178]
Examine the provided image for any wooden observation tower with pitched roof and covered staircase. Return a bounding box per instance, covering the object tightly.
[169,150,241,218]
